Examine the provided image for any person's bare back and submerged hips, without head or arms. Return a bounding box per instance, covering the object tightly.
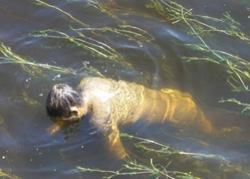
[80,77,207,130]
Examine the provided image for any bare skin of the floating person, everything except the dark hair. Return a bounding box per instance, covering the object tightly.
[47,77,214,159]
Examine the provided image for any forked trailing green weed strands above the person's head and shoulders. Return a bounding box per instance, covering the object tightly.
[30,25,153,68]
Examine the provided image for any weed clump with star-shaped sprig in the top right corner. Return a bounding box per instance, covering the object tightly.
[146,0,250,43]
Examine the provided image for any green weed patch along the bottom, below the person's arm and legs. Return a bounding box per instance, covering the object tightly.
[72,133,249,179]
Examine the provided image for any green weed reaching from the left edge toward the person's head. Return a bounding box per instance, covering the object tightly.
[0,43,76,75]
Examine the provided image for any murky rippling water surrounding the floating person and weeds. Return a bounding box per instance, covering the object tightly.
[0,0,250,178]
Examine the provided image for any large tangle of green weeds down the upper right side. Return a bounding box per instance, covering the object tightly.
[147,0,250,115]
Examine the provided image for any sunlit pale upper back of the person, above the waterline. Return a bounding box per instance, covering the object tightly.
[79,77,144,125]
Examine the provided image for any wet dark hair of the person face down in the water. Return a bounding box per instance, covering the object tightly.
[46,84,83,117]
